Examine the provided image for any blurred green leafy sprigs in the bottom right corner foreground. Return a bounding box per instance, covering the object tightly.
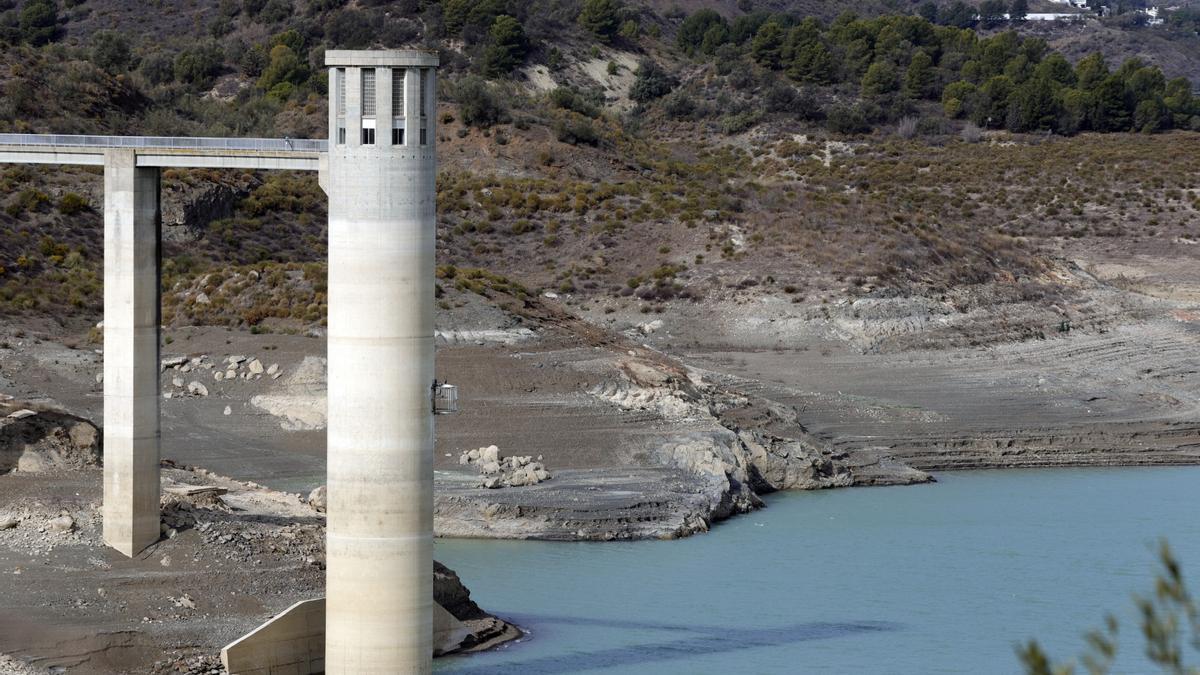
[1018,542,1200,675]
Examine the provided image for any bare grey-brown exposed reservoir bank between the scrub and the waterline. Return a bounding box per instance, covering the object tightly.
[0,234,1200,673]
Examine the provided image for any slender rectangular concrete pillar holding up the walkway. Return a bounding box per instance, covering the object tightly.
[103,150,161,556]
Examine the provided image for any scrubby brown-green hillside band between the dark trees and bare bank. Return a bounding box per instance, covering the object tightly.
[7,129,1200,330]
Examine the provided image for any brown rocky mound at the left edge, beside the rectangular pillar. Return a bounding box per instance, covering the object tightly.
[0,405,101,474]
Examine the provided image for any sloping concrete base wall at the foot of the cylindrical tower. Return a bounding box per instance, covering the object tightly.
[221,598,470,675]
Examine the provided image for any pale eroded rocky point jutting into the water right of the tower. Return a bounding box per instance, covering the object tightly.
[434,331,932,540]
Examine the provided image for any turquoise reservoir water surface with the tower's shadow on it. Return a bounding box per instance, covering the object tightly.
[436,467,1200,675]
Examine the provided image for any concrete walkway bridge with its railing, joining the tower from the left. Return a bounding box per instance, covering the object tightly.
[0,133,328,171]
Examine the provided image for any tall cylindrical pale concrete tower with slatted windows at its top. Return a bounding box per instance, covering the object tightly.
[322,50,438,675]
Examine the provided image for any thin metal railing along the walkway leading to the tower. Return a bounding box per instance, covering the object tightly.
[0,133,329,153]
